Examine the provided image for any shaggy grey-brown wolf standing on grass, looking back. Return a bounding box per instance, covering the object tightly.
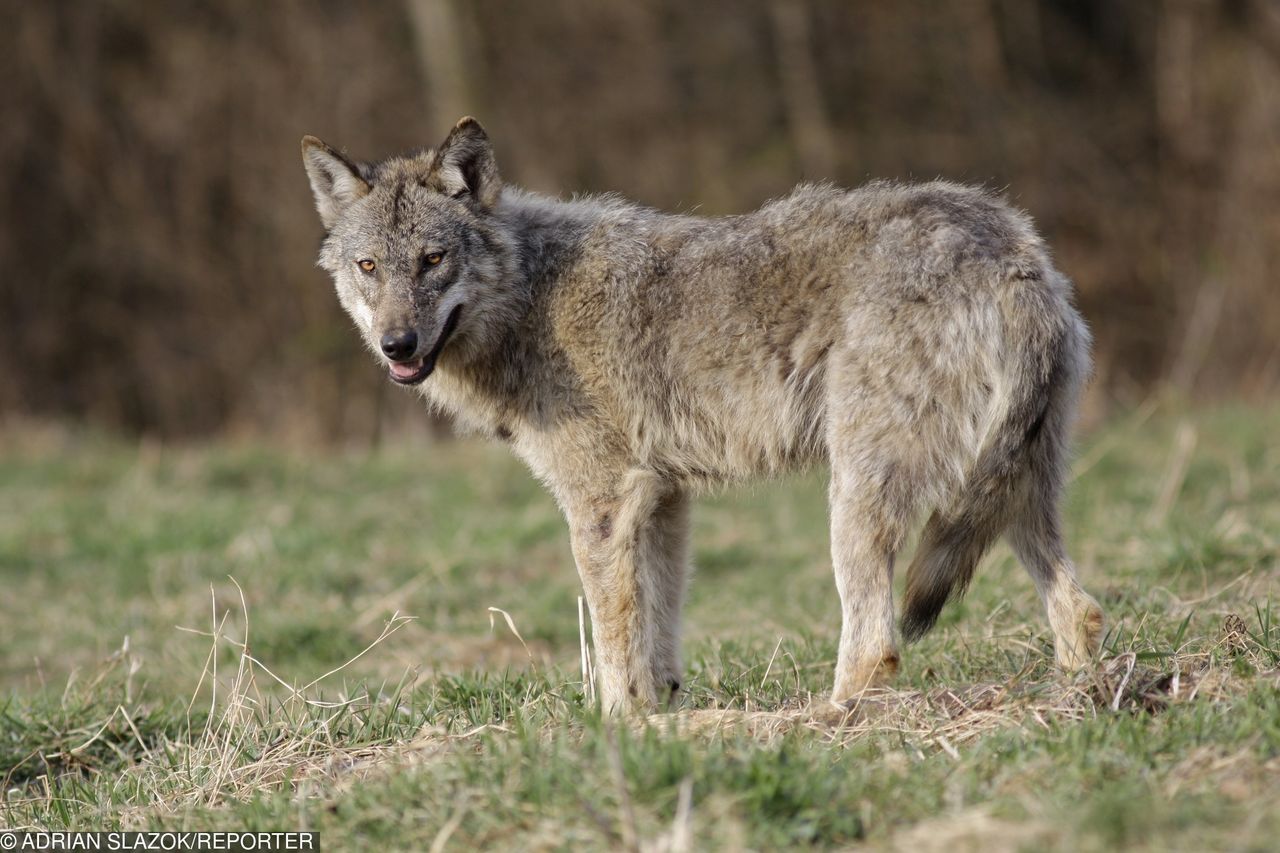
[302,118,1102,711]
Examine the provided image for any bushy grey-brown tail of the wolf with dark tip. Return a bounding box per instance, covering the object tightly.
[902,268,1088,642]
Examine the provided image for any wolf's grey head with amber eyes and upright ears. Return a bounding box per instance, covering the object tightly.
[302,118,520,386]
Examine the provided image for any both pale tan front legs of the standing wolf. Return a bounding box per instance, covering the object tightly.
[567,469,689,713]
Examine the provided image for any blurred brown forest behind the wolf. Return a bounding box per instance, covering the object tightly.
[0,0,1280,441]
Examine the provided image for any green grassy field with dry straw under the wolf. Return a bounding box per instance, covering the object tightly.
[0,406,1280,852]
